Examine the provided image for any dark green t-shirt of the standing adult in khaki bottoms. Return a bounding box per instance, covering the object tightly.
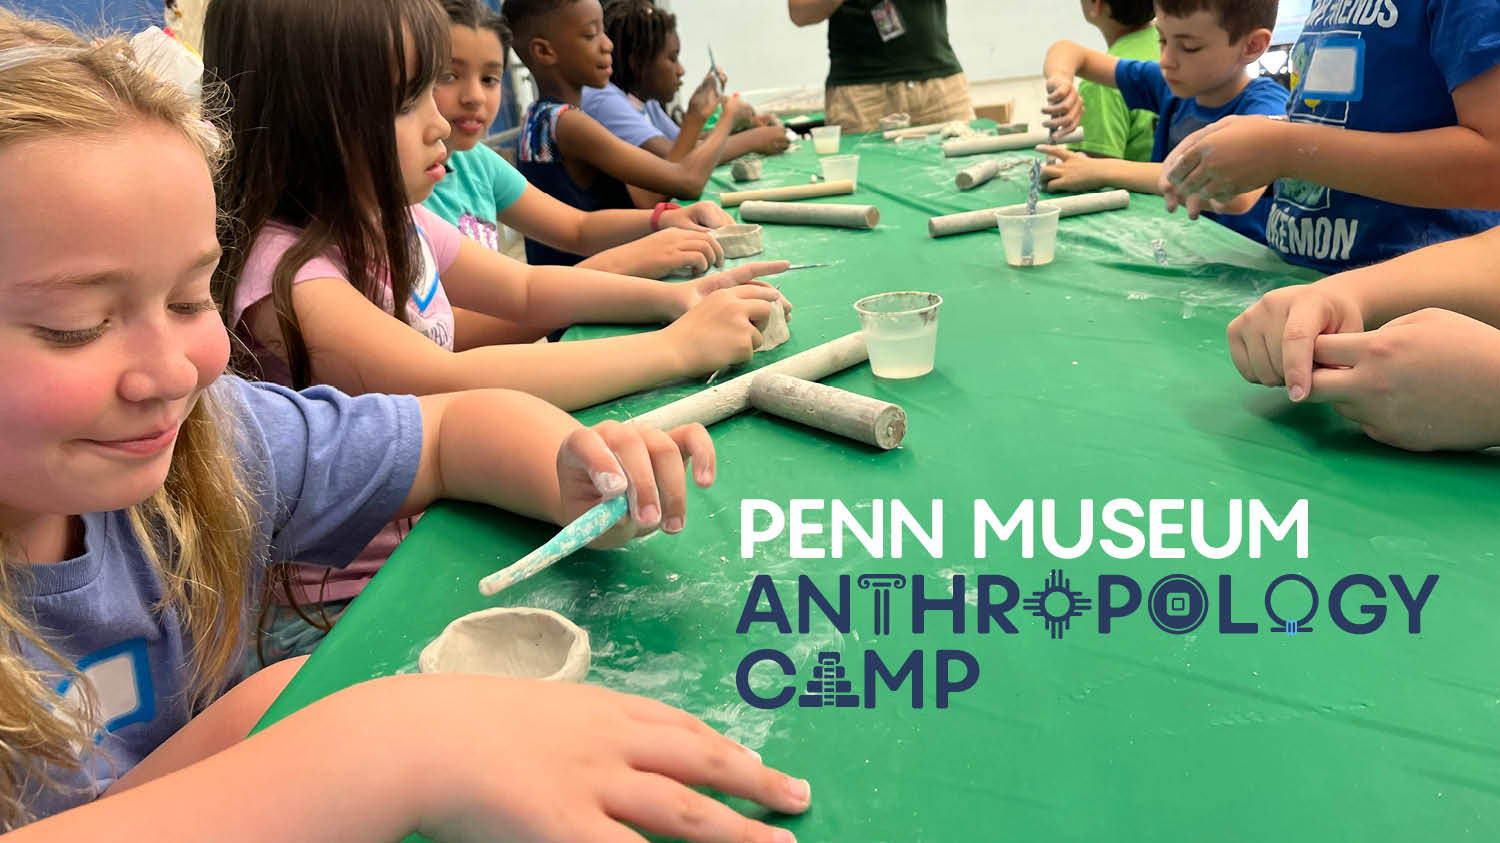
[828,0,963,87]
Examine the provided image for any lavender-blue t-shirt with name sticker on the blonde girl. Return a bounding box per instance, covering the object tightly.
[17,377,422,819]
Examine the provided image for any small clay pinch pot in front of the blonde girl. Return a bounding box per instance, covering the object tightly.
[417,608,590,683]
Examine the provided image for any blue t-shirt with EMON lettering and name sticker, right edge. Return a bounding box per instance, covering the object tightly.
[1266,0,1500,272]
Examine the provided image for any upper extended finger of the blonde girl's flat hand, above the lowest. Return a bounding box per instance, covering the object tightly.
[627,729,810,813]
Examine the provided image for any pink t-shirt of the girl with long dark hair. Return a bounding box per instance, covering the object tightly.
[230,206,464,603]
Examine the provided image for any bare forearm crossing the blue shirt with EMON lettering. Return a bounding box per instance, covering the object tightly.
[1278,123,1500,209]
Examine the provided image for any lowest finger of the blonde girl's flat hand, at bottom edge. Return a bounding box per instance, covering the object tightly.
[603,774,792,843]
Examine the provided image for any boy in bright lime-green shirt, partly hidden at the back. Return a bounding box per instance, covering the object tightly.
[1070,0,1161,161]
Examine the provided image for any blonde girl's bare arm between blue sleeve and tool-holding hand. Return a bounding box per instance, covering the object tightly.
[401,389,579,524]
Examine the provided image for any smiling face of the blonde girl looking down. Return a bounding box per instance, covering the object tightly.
[0,122,230,530]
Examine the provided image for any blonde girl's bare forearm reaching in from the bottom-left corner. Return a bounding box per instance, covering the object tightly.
[6,680,426,843]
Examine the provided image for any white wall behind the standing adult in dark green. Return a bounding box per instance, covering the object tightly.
[657,0,1104,90]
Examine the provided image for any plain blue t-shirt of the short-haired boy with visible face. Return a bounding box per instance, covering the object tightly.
[1115,59,1287,243]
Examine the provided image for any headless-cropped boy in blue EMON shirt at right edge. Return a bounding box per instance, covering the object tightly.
[1161,0,1500,272]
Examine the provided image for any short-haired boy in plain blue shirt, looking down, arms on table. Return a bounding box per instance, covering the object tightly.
[1038,0,1287,243]
